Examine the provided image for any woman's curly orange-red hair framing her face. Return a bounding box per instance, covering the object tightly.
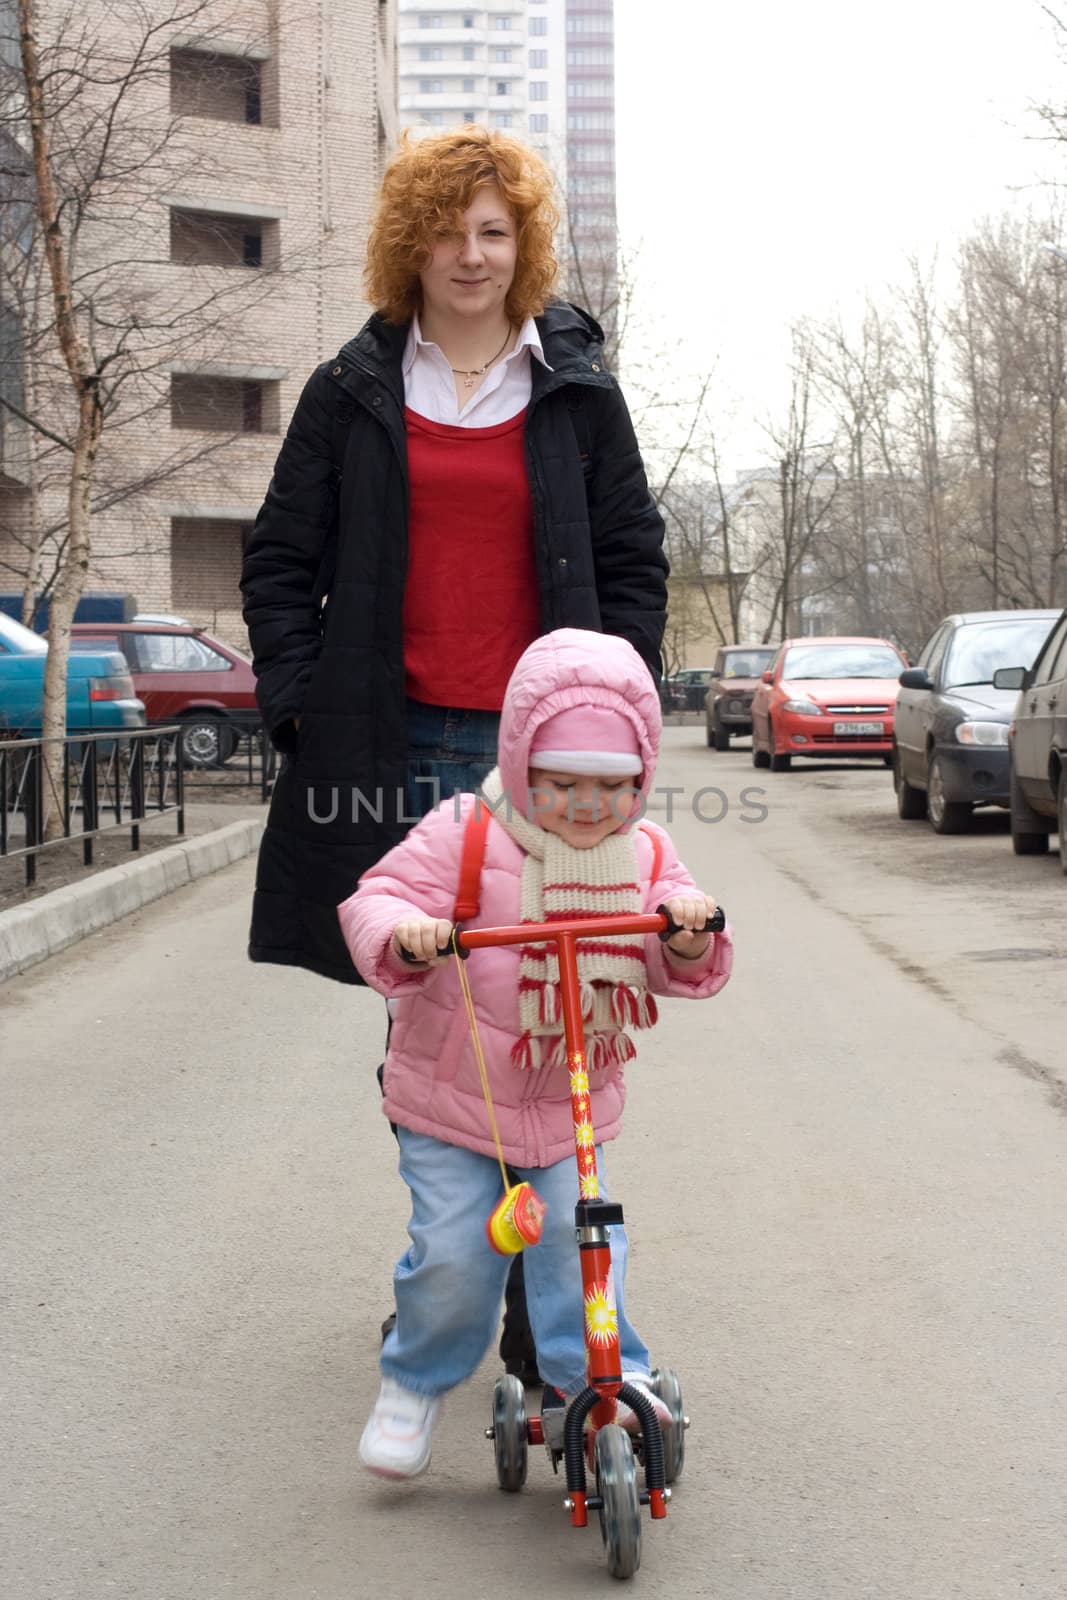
[363,125,560,323]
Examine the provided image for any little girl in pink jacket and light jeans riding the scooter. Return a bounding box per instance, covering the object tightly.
[339,629,731,1478]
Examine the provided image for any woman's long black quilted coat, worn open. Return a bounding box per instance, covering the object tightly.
[242,304,667,982]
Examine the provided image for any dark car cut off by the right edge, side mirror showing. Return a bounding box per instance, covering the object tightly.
[993,611,1067,872]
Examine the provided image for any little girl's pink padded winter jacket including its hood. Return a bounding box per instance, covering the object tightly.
[339,629,733,1166]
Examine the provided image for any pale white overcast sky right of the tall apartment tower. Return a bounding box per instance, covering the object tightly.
[616,0,1067,475]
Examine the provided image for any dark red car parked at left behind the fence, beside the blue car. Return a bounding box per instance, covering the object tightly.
[70,622,259,766]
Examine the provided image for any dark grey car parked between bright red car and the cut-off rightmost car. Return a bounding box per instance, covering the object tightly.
[893,611,1059,834]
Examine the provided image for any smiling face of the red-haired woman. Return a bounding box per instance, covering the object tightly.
[419,184,518,322]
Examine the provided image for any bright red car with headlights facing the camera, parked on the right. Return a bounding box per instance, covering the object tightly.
[752,638,907,773]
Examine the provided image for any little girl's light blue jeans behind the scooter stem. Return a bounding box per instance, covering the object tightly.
[381,1128,649,1395]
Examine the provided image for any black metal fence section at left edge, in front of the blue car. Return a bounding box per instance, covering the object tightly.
[0,725,186,885]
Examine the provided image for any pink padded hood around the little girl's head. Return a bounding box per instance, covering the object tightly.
[498,627,662,814]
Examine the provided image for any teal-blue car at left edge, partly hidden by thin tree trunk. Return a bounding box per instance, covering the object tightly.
[0,613,144,739]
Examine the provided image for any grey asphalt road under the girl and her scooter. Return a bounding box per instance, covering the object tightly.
[0,726,1067,1600]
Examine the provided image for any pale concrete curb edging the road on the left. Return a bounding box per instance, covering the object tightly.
[0,818,264,984]
